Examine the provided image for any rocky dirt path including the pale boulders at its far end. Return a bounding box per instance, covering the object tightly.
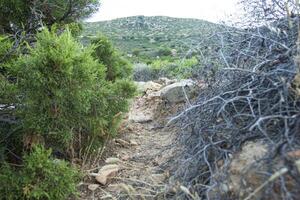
[80,79,192,199]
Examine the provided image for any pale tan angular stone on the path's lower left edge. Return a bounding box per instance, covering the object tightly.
[96,165,120,185]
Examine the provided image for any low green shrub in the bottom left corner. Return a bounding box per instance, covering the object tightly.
[0,147,80,200]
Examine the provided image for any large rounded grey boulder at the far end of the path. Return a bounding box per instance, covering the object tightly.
[160,80,197,104]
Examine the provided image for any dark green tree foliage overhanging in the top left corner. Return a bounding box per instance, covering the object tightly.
[0,0,99,33]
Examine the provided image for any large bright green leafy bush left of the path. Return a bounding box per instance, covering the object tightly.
[11,30,135,153]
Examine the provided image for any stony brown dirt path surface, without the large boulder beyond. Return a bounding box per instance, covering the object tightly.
[82,85,180,199]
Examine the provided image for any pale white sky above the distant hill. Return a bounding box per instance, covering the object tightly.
[87,0,238,22]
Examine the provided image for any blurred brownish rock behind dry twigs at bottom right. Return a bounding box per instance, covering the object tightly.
[209,141,268,199]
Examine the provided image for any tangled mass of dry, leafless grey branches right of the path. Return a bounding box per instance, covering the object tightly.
[167,13,300,199]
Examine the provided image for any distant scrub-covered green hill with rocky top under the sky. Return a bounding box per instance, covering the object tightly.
[82,16,222,61]
